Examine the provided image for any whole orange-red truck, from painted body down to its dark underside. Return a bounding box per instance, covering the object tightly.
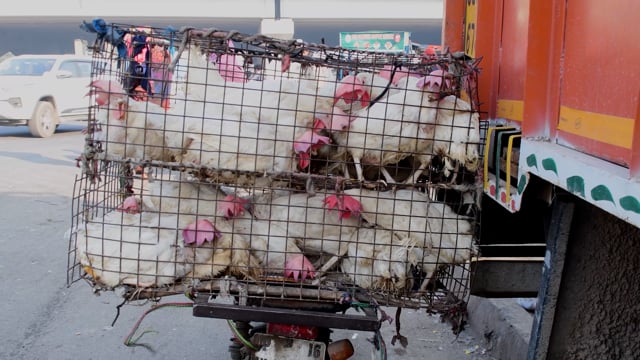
[450,0,640,359]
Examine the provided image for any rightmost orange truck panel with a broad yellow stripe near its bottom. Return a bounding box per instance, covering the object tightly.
[558,0,640,166]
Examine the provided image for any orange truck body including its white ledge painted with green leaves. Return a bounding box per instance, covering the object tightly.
[443,0,640,227]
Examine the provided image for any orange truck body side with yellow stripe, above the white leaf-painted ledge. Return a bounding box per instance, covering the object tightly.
[450,0,640,169]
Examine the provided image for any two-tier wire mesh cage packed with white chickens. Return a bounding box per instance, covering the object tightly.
[68,24,482,318]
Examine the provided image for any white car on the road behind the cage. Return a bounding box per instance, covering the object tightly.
[0,55,97,137]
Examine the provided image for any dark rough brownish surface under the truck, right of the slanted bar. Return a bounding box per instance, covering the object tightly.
[547,200,640,359]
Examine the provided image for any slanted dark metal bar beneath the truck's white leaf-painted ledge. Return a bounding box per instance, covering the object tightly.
[527,198,575,360]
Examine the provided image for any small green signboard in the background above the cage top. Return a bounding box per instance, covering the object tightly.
[340,31,411,53]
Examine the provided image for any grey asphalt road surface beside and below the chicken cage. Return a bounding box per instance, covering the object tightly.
[0,123,492,360]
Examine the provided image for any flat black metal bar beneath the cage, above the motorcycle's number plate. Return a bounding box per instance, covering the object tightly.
[193,303,380,331]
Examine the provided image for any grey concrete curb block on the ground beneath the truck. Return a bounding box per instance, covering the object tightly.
[467,296,533,360]
